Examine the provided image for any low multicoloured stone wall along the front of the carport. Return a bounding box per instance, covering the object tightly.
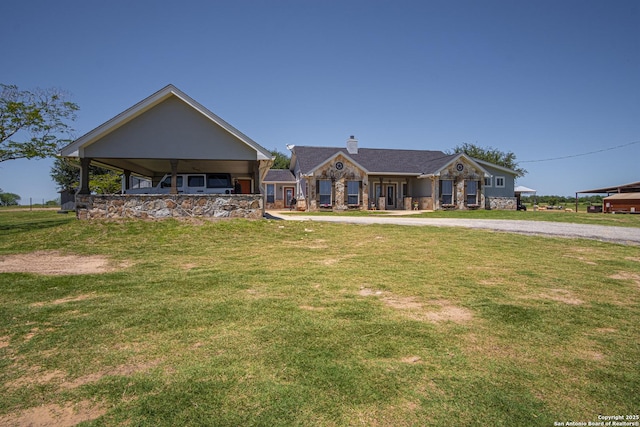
[76,194,264,219]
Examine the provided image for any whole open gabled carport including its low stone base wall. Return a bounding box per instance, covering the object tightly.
[60,85,273,221]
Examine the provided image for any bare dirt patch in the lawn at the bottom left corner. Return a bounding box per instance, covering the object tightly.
[0,400,106,427]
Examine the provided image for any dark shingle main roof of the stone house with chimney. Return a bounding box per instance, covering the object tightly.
[293,146,457,175]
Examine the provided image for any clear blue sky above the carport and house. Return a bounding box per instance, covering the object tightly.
[0,0,640,204]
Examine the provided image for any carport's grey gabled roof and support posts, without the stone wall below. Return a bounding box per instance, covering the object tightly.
[60,85,273,221]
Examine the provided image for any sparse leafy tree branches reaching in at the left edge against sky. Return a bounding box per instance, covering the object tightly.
[0,84,78,162]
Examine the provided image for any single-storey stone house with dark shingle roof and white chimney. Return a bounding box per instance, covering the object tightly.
[264,136,517,211]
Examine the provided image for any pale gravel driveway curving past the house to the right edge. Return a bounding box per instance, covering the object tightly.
[271,213,640,246]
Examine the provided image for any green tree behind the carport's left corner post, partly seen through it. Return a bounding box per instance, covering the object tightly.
[50,158,122,194]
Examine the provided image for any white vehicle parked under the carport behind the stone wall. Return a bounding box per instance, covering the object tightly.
[125,173,233,194]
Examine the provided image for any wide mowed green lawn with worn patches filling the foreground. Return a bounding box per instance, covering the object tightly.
[0,212,640,426]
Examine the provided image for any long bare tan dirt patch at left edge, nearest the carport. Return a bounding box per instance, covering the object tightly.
[0,251,127,276]
